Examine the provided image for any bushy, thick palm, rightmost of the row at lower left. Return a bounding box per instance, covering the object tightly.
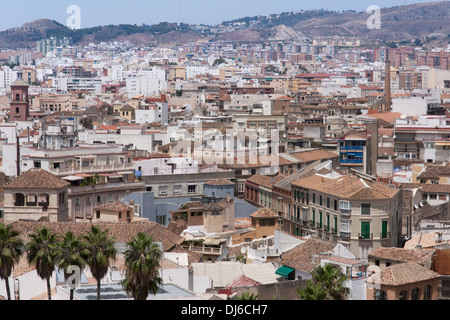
[122,232,162,300]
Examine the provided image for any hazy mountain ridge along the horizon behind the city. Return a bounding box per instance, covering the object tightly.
[0,1,450,49]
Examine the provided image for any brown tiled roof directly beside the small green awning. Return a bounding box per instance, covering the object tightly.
[280,238,338,272]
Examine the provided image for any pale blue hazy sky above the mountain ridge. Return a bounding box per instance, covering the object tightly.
[0,0,442,30]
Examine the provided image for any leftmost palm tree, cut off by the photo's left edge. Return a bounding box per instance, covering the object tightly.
[0,223,24,300]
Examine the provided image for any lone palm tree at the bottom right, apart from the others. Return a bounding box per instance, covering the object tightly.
[297,263,350,300]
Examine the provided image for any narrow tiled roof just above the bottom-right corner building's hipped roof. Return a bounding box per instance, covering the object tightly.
[369,247,435,268]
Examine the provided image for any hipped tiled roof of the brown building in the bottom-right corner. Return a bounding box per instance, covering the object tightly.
[366,262,440,286]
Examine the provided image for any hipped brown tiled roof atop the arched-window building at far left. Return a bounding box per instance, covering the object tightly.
[4,168,70,189]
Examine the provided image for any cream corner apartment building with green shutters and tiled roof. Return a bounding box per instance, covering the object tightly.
[286,173,402,259]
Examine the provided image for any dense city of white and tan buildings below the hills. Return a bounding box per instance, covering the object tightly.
[0,1,450,304]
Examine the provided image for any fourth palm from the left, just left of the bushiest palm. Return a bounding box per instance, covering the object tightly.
[84,225,117,300]
